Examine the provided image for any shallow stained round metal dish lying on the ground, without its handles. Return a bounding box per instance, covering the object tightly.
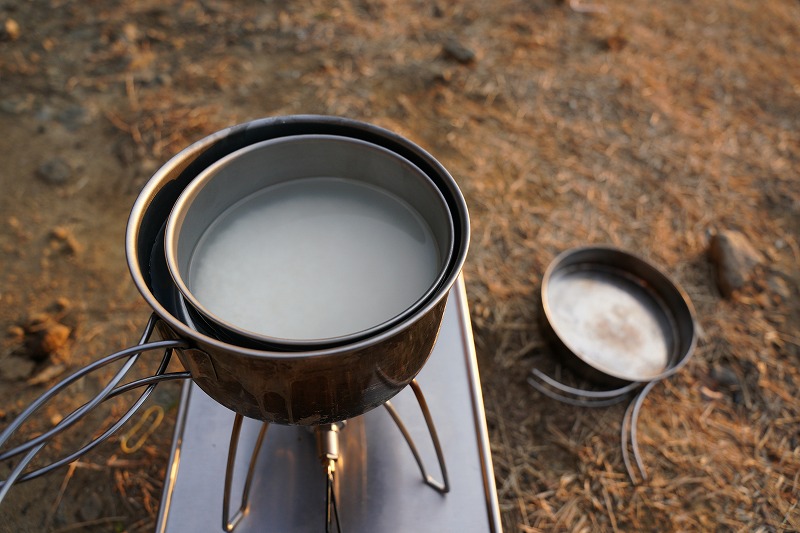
[541,246,696,385]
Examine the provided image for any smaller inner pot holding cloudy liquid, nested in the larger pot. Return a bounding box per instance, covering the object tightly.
[165,135,453,350]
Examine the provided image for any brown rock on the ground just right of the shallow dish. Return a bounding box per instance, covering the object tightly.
[708,230,763,298]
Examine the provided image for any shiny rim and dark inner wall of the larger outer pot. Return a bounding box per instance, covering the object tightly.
[125,115,470,360]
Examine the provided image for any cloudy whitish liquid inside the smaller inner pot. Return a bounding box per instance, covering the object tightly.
[188,178,439,340]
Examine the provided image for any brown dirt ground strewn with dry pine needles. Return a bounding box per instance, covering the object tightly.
[0,0,800,532]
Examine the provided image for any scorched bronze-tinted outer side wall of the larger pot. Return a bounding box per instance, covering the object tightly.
[153,299,447,425]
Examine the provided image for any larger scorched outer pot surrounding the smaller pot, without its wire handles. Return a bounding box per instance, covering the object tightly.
[126,116,469,425]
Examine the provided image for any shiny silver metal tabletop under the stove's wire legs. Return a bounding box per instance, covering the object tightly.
[156,278,501,533]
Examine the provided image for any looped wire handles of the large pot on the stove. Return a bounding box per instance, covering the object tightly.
[0,313,191,504]
